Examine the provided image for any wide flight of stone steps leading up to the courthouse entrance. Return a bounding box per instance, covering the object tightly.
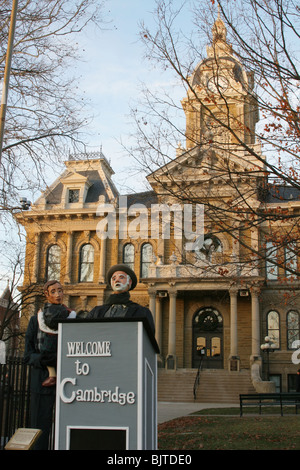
[158,369,255,403]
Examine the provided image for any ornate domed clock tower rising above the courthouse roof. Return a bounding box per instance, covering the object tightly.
[182,16,258,149]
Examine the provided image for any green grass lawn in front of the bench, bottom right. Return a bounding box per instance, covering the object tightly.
[158,408,300,450]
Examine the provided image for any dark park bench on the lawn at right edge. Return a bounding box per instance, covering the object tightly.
[240,393,300,416]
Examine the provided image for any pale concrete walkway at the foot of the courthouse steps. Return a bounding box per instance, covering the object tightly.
[157,401,239,424]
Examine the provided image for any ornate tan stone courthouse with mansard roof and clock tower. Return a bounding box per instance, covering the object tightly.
[17,19,300,402]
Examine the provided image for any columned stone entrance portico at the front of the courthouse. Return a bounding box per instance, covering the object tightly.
[147,264,260,370]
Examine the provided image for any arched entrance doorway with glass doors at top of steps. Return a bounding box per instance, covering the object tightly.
[192,307,223,369]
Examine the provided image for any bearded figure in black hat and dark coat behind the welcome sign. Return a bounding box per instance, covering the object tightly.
[87,264,155,333]
